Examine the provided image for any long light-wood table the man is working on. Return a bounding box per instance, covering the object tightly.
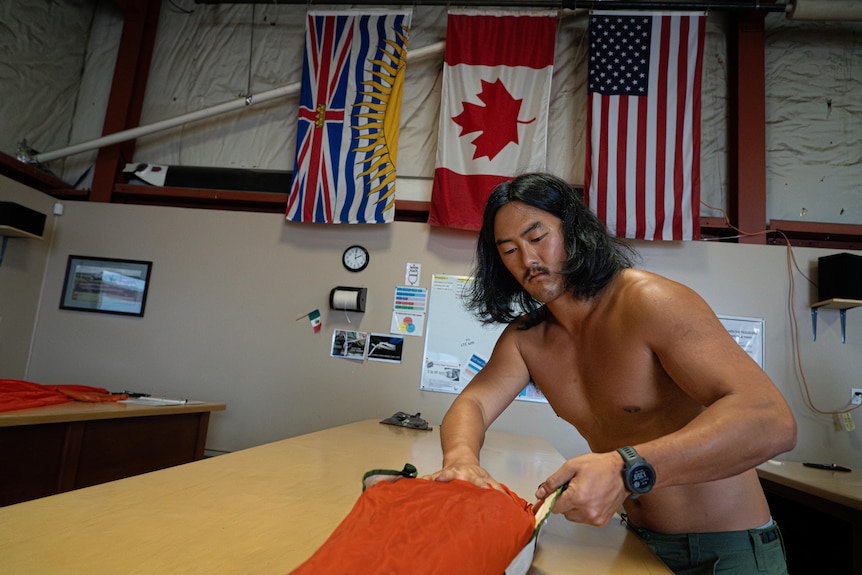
[0,420,670,575]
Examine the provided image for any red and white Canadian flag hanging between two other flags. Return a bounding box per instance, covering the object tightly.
[428,10,557,230]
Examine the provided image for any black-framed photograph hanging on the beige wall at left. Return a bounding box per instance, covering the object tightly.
[60,256,153,317]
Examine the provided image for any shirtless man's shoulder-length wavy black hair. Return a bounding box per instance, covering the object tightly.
[466,173,636,329]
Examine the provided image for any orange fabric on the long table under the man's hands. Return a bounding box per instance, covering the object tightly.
[291,479,536,575]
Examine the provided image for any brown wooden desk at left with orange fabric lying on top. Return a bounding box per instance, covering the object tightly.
[0,402,225,505]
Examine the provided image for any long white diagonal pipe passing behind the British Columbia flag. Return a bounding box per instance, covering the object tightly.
[30,42,446,164]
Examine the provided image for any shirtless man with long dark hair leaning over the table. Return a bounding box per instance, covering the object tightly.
[428,174,796,574]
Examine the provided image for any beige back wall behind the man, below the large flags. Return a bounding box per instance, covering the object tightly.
[6,181,862,467]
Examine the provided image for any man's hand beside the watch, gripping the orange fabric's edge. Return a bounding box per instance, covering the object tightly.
[536,451,628,527]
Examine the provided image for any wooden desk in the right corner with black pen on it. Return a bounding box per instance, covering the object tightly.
[757,461,862,575]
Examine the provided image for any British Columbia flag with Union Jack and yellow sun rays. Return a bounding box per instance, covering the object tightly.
[286,10,412,223]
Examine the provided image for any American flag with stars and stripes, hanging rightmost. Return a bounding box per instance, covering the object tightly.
[585,12,706,240]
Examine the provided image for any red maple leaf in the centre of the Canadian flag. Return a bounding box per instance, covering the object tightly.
[452,78,535,160]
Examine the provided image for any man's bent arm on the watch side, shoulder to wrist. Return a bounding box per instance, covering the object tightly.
[633,278,796,487]
